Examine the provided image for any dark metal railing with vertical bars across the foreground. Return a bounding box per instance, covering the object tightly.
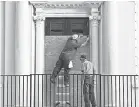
[0,74,139,107]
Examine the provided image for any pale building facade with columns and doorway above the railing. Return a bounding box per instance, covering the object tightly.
[0,1,139,107]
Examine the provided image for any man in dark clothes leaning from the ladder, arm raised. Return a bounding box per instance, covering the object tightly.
[51,34,89,86]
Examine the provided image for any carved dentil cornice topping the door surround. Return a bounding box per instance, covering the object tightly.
[30,1,103,8]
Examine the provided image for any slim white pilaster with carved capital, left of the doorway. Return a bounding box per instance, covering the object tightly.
[34,16,45,74]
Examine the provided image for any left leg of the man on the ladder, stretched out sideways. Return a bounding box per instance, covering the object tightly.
[51,59,62,83]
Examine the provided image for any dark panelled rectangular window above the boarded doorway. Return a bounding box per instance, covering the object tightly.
[45,18,89,36]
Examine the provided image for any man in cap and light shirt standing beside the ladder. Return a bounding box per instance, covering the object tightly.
[80,55,96,107]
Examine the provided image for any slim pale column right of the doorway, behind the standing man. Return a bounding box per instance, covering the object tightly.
[89,10,100,73]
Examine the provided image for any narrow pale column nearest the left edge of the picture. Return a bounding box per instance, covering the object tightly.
[4,1,16,106]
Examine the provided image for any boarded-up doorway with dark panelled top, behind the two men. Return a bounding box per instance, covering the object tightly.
[44,17,90,74]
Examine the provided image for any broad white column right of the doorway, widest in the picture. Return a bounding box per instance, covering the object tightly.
[102,1,138,106]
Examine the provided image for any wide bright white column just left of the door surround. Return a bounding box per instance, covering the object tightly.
[15,1,32,75]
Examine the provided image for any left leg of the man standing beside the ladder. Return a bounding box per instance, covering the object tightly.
[83,81,90,107]
